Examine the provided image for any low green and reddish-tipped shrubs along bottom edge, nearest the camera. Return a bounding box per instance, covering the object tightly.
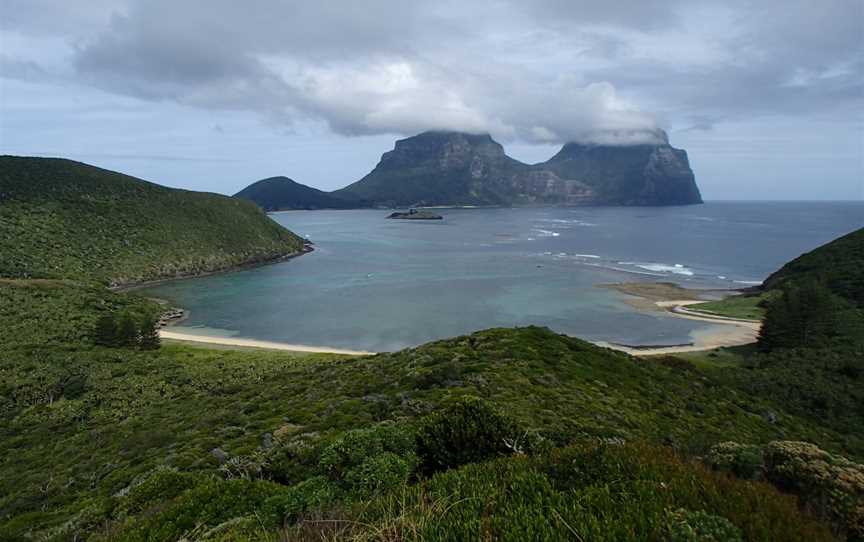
[318,443,835,542]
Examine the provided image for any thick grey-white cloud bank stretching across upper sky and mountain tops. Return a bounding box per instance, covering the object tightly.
[0,0,864,148]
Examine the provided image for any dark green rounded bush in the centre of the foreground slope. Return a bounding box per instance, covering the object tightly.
[417,397,526,473]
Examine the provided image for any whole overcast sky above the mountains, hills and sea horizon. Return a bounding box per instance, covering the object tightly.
[0,0,864,200]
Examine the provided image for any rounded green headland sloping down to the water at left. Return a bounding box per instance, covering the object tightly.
[0,156,303,285]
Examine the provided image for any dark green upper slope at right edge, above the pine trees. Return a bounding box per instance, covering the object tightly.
[763,228,864,307]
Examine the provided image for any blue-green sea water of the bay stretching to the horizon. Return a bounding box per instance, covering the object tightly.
[143,202,864,351]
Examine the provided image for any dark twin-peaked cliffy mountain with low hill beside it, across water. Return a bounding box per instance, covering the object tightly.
[235,132,702,211]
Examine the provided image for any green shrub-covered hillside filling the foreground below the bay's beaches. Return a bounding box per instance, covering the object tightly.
[0,280,864,540]
